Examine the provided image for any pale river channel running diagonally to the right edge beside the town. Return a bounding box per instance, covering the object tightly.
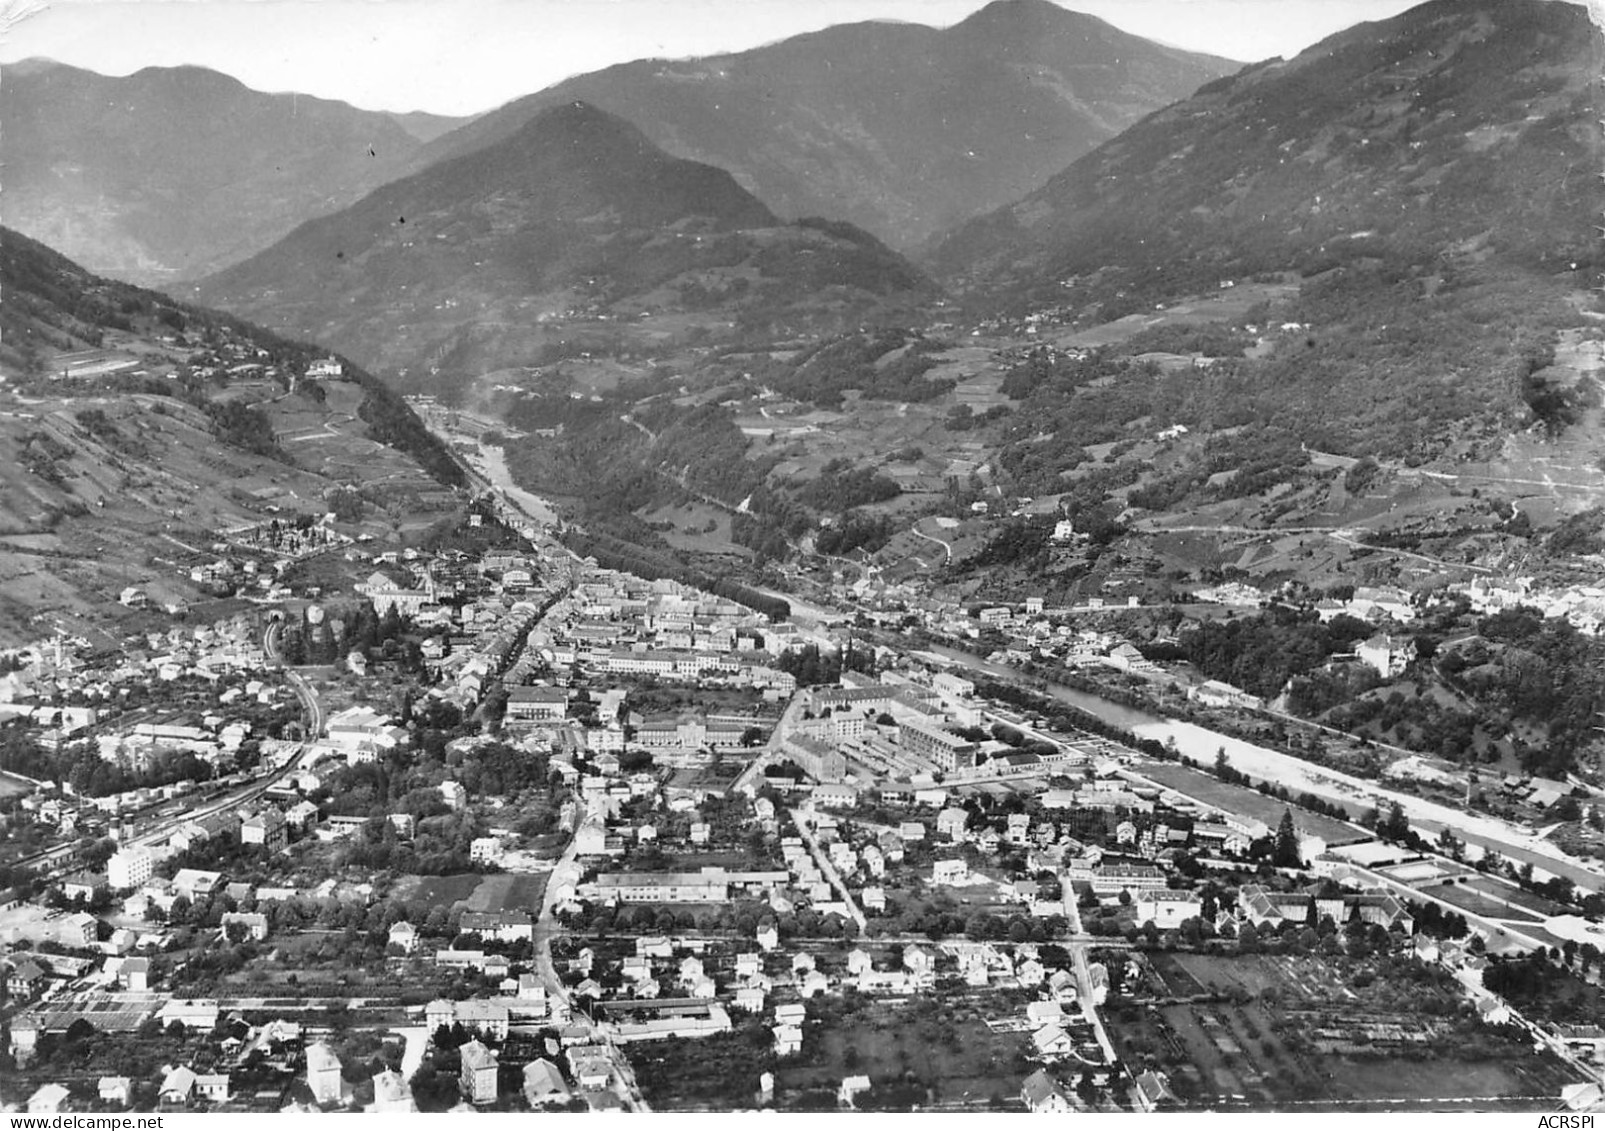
[931,645,1605,890]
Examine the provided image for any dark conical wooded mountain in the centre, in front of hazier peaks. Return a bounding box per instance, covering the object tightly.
[196,103,936,374]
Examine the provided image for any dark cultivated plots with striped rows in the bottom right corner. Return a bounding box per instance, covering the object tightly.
[1109,953,1576,1110]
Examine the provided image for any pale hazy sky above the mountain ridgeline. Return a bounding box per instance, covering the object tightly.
[0,0,1444,114]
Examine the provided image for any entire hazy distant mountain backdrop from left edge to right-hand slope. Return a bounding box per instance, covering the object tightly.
[0,0,1237,293]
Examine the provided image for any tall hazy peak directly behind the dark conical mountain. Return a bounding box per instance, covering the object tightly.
[412,0,1242,252]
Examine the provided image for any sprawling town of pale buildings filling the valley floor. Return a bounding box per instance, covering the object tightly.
[0,468,1605,1112]
